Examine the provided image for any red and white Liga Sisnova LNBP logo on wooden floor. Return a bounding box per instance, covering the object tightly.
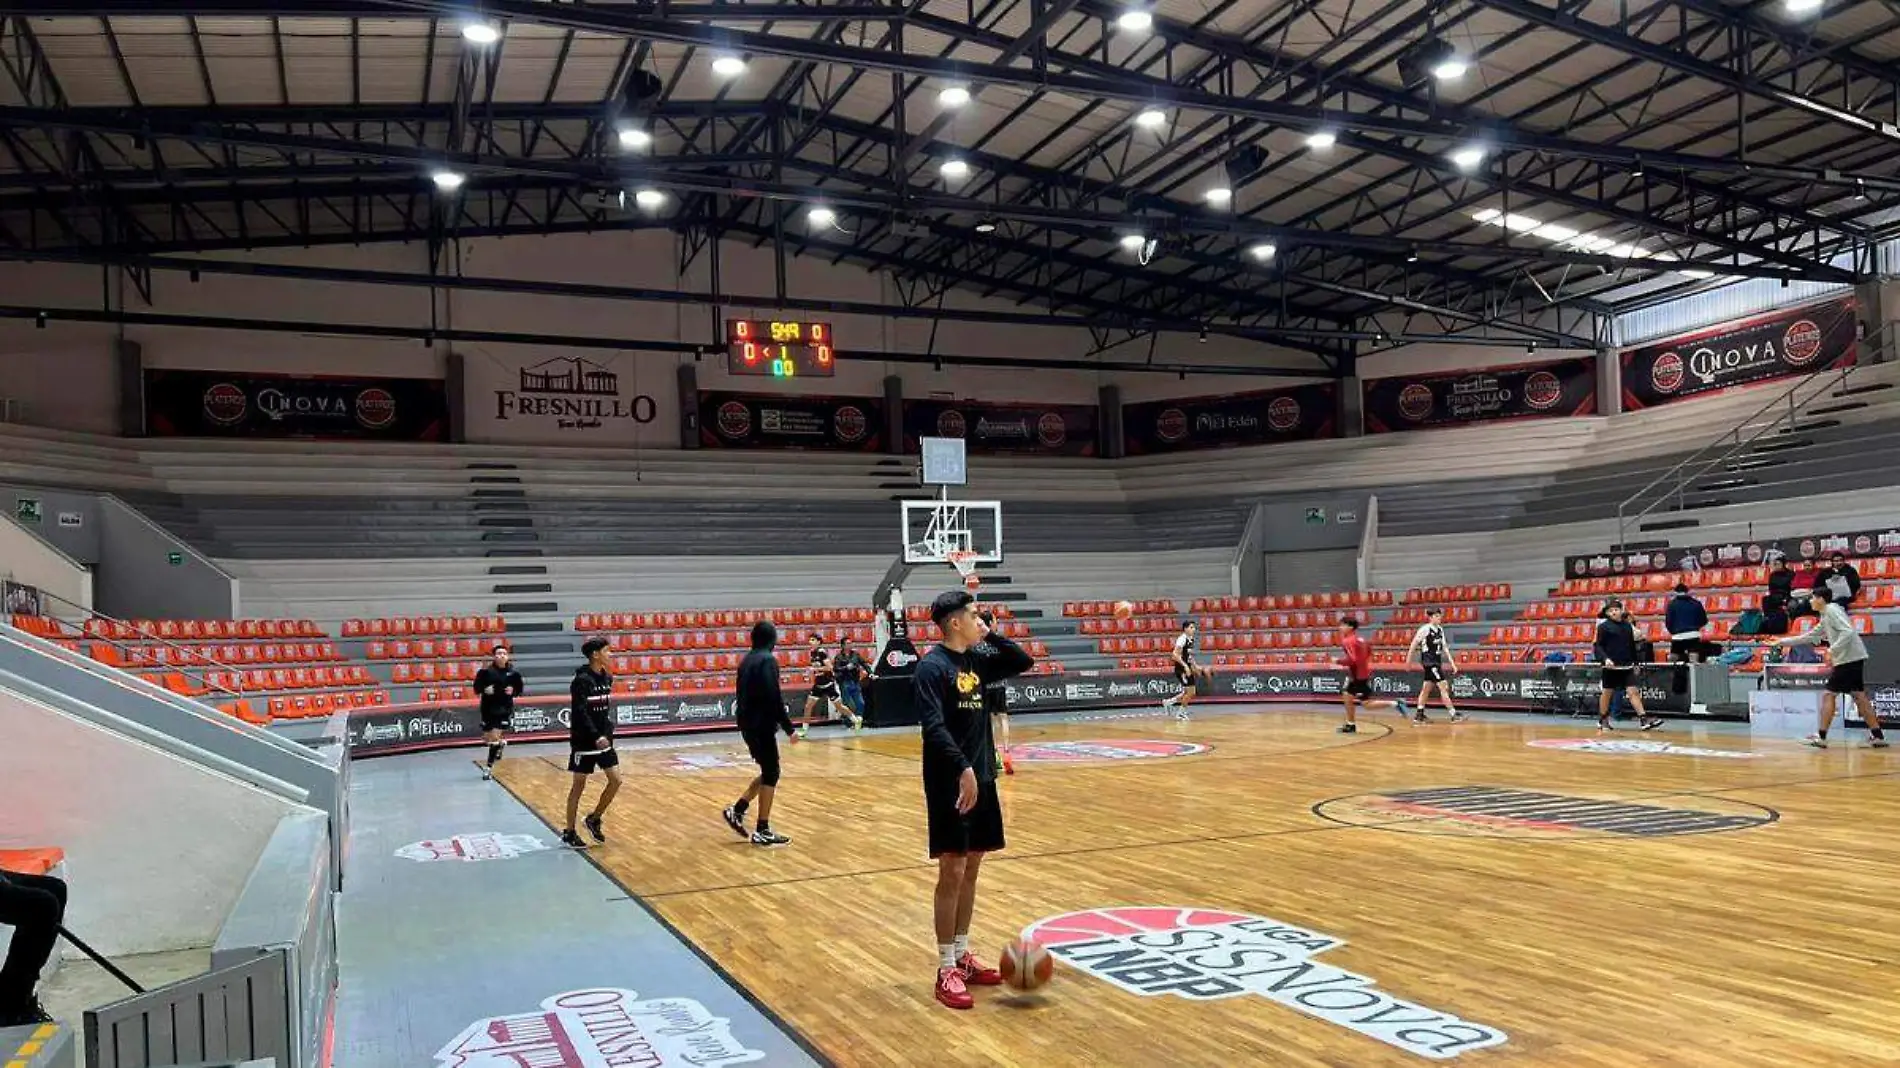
[1024,906,1509,1060]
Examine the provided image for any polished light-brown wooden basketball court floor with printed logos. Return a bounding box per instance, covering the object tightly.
[502,709,1900,1068]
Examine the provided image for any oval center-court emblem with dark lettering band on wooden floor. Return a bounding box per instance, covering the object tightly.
[1313,787,1780,840]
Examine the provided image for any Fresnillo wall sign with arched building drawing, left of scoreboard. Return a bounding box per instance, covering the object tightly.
[462,352,680,448]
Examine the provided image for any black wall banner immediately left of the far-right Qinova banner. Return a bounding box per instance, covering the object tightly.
[1364,355,1596,433]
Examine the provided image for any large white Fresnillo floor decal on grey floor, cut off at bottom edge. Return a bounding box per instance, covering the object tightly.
[435,988,766,1068]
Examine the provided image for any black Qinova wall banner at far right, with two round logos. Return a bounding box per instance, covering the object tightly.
[1621,296,1858,410]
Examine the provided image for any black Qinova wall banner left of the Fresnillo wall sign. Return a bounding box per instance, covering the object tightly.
[144,369,448,441]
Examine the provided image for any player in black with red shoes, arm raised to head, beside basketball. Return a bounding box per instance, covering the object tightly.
[912,589,1036,1009]
